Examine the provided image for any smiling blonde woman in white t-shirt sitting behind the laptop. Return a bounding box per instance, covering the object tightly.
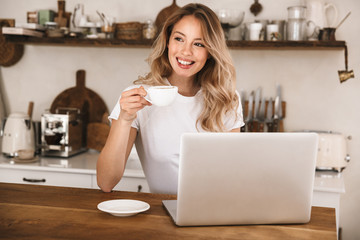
[97,4,244,194]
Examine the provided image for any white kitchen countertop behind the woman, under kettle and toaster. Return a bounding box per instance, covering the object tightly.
[0,150,345,193]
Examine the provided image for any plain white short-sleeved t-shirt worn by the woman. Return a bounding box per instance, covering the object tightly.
[109,85,244,194]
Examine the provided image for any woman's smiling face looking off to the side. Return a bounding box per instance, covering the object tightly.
[168,15,209,81]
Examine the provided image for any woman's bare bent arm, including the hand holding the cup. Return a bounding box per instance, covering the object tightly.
[96,87,151,192]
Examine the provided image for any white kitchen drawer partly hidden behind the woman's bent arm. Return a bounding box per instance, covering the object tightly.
[93,175,150,192]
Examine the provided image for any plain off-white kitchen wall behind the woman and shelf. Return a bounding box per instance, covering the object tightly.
[0,0,360,239]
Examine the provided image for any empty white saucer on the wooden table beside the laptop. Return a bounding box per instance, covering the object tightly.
[97,199,150,217]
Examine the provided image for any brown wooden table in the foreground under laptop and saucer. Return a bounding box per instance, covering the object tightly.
[0,183,337,240]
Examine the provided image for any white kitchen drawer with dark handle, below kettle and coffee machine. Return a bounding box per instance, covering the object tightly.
[0,169,92,188]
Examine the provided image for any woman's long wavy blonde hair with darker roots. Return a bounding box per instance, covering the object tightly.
[134,3,239,132]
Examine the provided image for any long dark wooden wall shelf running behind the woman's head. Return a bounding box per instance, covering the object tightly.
[5,35,346,50]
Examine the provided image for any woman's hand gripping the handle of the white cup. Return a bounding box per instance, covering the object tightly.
[119,86,152,122]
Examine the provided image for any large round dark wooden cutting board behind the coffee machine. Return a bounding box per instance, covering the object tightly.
[50,70,109,124]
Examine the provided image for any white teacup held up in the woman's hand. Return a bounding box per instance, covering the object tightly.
[145,86,178,107]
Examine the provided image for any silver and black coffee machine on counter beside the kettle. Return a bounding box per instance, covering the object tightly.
[41,108,87,157]
